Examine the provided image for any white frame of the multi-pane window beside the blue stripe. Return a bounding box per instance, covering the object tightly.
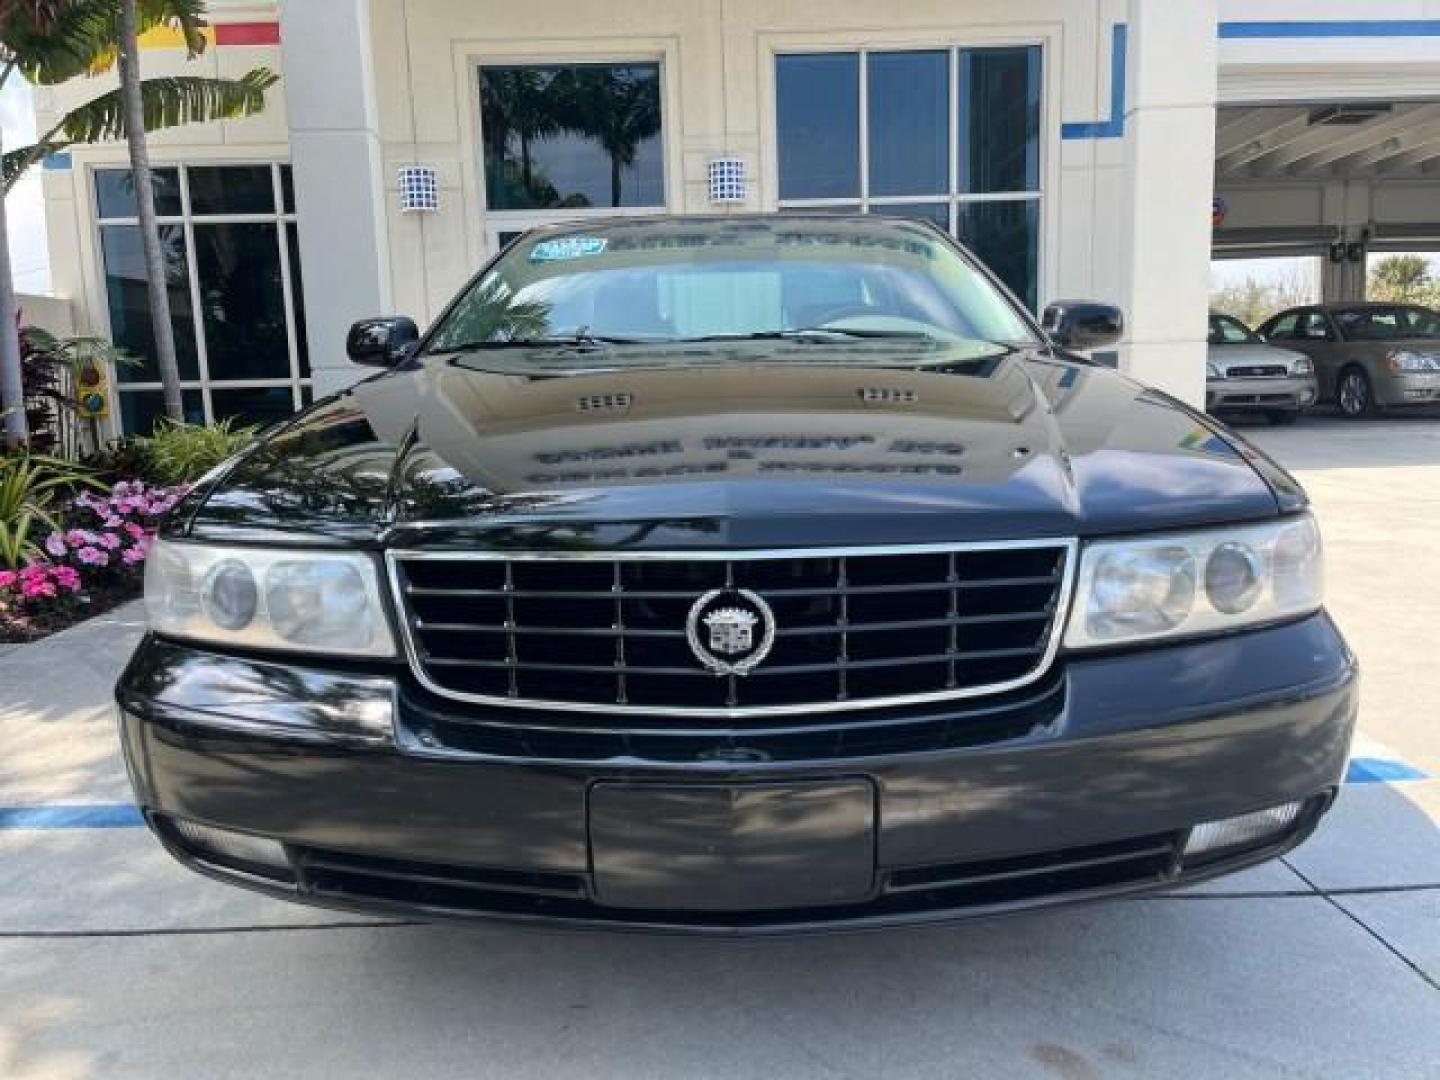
[760,38,1060,314]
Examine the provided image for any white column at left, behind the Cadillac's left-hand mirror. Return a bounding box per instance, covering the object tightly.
[279,0,390,397]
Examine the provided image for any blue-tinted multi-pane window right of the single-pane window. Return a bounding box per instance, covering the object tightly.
[775,45,1041,308]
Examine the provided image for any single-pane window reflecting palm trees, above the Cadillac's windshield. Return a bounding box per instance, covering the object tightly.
[480,63,665,212]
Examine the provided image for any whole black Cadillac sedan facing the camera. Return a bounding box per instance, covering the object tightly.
[117,215,1356,933]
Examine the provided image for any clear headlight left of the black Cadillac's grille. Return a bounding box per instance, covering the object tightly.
[145,541,395,657]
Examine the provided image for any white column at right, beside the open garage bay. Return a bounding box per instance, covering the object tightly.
[1120,0,1218,406]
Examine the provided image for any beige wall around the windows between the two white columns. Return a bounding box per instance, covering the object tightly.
[368,0,1128,329]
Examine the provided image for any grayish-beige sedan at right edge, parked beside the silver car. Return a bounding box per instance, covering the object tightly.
[1260,304,1440,418]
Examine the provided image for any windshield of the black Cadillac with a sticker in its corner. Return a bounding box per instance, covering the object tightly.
[426,216,1037,360]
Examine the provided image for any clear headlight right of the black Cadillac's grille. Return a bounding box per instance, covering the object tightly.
[1066,514,1323,648]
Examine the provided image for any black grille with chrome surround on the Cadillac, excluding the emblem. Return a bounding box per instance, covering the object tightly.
[390,540,1074,717]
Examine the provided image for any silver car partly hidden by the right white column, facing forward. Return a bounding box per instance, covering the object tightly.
[1205,311,1319,423]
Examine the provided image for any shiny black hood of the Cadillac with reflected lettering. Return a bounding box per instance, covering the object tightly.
[183,343,1303,549]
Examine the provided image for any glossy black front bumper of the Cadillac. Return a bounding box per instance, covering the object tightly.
[118,613,1358,933]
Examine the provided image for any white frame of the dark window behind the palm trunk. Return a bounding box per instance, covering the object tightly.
[85,156,314,435]
